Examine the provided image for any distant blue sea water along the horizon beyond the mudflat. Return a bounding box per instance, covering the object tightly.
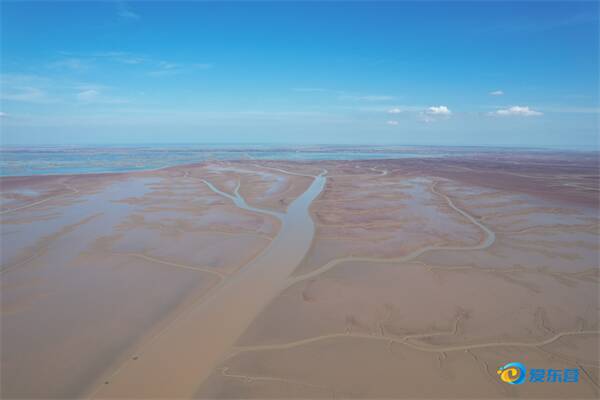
[0,144,592,176]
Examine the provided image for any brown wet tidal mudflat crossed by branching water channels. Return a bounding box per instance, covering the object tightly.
[0,153,600,398]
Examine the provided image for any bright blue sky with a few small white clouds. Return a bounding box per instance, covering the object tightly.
[0,0,600,149]
